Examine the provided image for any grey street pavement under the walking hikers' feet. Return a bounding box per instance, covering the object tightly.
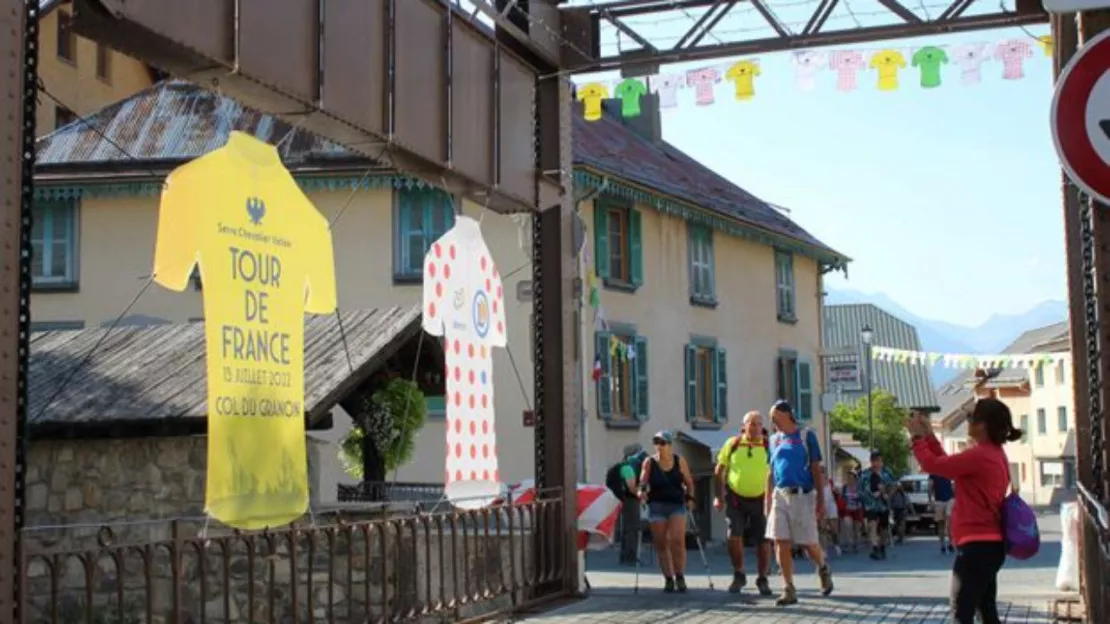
[515,514,1074,624]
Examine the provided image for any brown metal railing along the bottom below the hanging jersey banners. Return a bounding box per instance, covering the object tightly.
[21,491,563,624]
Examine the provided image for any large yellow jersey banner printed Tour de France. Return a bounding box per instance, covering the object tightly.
[154,132,335,529]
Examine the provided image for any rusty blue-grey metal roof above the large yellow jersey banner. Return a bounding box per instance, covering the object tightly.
[36,80,365,170]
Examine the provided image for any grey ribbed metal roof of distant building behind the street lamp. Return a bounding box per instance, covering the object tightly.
[823,303,940,410]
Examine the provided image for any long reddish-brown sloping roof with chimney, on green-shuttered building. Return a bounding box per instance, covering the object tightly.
[574,101,847,260]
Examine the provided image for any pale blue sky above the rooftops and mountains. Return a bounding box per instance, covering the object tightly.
[555,0,1067,325]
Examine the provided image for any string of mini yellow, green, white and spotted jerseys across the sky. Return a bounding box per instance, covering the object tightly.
[577,34,1053,121]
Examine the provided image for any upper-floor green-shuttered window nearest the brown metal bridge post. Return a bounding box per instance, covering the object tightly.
[594,199,644,289]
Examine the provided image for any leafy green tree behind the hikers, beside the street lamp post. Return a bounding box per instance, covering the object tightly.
[829,390,909,476]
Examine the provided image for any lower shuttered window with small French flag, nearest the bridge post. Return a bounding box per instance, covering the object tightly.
[594,330,648,426]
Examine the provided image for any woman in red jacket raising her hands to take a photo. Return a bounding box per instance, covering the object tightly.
[907,399,1021,624]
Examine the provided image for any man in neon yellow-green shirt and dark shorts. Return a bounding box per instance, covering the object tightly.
[713,411,770,596]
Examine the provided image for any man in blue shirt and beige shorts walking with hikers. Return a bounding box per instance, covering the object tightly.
[764,400,835,606]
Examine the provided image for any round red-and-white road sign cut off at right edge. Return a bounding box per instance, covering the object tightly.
[1050,31,1110,203]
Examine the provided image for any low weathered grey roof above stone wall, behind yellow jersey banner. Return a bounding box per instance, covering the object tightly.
[28,306,421,436]
